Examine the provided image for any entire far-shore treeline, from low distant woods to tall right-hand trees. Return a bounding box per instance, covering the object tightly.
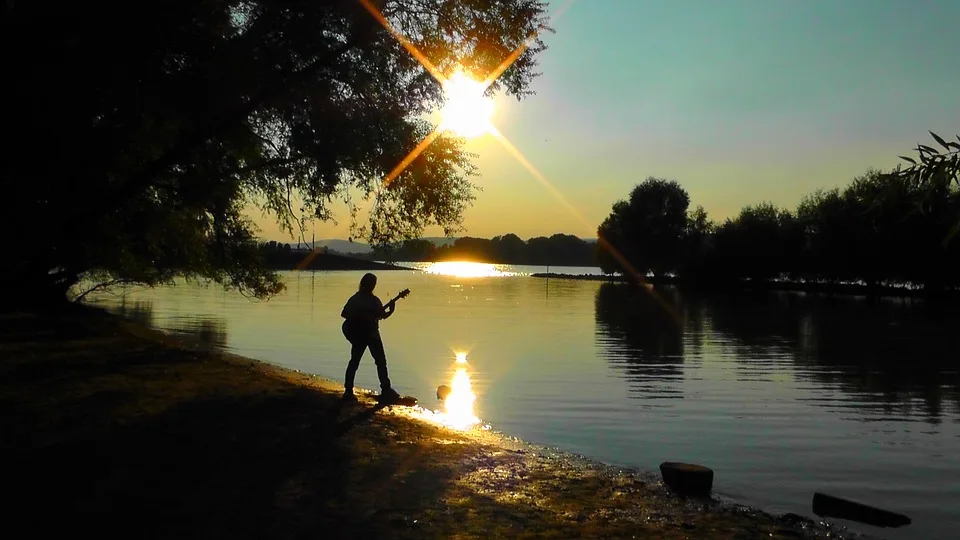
[255,170,960,298]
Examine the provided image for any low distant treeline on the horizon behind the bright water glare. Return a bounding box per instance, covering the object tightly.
[368,233,597,266]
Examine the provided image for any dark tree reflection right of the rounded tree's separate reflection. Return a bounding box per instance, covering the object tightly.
[708,293,960,422]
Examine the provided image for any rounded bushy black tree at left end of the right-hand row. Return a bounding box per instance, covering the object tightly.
[597,177,690,275]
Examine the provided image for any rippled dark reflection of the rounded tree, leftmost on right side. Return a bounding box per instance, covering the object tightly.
[595,283,684,398]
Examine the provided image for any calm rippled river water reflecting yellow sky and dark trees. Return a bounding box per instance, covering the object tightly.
[82,264,960,538]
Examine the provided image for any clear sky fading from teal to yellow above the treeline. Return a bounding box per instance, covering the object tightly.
[251,0,960,240]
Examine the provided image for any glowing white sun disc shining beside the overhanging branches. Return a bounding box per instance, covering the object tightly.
[440,71,493,138]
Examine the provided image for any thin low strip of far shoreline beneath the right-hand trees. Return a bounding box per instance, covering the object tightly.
[530,272,960,300]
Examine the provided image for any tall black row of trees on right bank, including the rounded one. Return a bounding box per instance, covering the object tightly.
[598,135,960,291]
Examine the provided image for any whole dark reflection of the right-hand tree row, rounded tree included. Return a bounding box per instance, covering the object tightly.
[596,284,960,423]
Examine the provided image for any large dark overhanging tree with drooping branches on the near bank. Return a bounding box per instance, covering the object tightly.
[0,0,546,306]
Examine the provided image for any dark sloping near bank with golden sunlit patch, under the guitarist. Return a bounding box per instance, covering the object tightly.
[0,306,856,538]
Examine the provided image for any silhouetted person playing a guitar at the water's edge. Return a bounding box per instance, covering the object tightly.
[340,273,400,403]
